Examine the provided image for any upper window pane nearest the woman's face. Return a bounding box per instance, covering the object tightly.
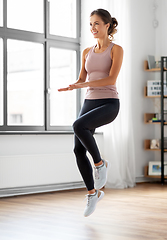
[50,0,76,38]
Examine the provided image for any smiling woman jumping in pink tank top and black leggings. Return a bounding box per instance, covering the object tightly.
[58,9,123,217]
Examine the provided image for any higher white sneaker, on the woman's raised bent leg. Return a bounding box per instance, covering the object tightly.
[95,160,110,189]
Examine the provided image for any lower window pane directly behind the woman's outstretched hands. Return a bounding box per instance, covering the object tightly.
[50,48,76,126]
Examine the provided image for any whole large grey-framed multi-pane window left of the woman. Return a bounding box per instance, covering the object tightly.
[0,0,81,133]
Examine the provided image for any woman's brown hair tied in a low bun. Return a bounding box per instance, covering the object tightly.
[90,8,118,40]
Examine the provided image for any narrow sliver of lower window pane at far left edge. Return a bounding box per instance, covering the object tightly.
[0,38,3,125]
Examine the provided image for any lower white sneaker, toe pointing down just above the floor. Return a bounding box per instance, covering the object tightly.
[84,191,104,217]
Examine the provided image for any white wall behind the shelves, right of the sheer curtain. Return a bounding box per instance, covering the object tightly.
[122,0,167,177]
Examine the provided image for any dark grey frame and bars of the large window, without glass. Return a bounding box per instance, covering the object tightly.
[0,0,81,134]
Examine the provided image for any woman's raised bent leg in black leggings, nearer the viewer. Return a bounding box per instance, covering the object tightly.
[73,99,119,163]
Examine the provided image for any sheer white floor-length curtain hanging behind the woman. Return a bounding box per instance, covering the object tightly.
[103,0,135,188]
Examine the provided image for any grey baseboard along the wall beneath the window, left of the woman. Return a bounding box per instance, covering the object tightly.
[0,181,85,198]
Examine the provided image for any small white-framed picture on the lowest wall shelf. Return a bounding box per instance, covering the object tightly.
[148,161,167,176]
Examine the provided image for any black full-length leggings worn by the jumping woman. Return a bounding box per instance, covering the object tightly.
[73,98,119,191]
